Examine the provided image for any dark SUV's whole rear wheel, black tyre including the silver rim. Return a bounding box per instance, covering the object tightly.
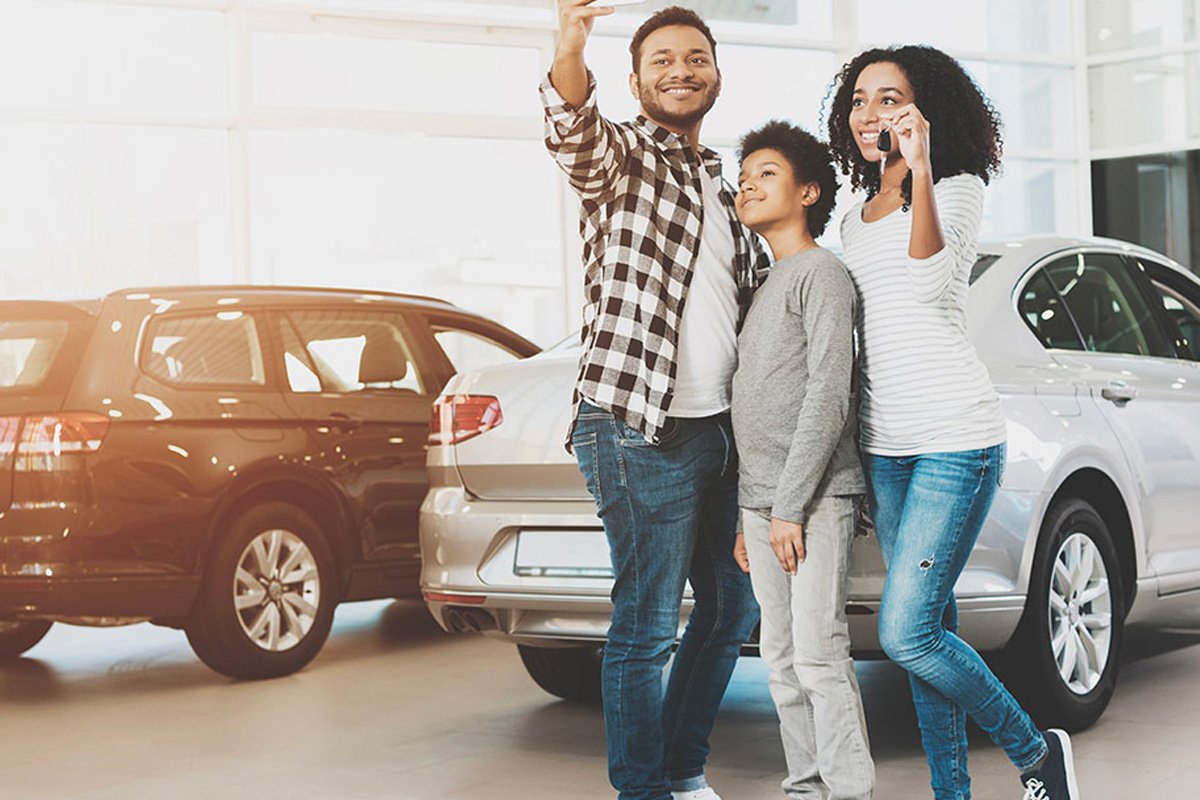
[184,503,337,680]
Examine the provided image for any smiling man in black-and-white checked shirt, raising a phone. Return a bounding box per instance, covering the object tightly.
[541,0,762,800]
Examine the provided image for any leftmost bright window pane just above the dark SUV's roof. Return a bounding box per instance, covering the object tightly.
[0,124,235,297]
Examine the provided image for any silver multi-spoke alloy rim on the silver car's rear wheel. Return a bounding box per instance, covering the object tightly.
[1049,533,1112,694]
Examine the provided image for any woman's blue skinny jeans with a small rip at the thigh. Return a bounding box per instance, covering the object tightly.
[863,445,1046,800]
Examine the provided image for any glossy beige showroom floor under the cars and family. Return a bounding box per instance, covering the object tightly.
[0,602,1200,800]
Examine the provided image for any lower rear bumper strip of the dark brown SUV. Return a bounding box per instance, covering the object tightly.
[0,576,200,619]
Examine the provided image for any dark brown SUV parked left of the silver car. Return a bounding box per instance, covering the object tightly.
[0,287,538,678]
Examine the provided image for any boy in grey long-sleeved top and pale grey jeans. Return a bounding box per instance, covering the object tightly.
[733,122,875,800]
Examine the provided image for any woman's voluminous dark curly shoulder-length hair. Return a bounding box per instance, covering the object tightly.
[826,44,1004,207]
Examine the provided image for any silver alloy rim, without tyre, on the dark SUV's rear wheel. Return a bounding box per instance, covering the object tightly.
[233,528,320,652]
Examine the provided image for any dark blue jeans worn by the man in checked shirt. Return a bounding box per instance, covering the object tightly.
[571,403,758,800]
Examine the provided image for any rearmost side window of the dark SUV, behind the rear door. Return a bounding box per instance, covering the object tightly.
[142,311,266,386]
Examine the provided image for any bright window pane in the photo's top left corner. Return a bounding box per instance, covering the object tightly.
[0,0,227,116]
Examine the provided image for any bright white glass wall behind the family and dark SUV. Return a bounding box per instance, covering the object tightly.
[0,0,1099,344]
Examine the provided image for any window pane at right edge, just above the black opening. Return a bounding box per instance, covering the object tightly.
[1087,54,1200,148]
